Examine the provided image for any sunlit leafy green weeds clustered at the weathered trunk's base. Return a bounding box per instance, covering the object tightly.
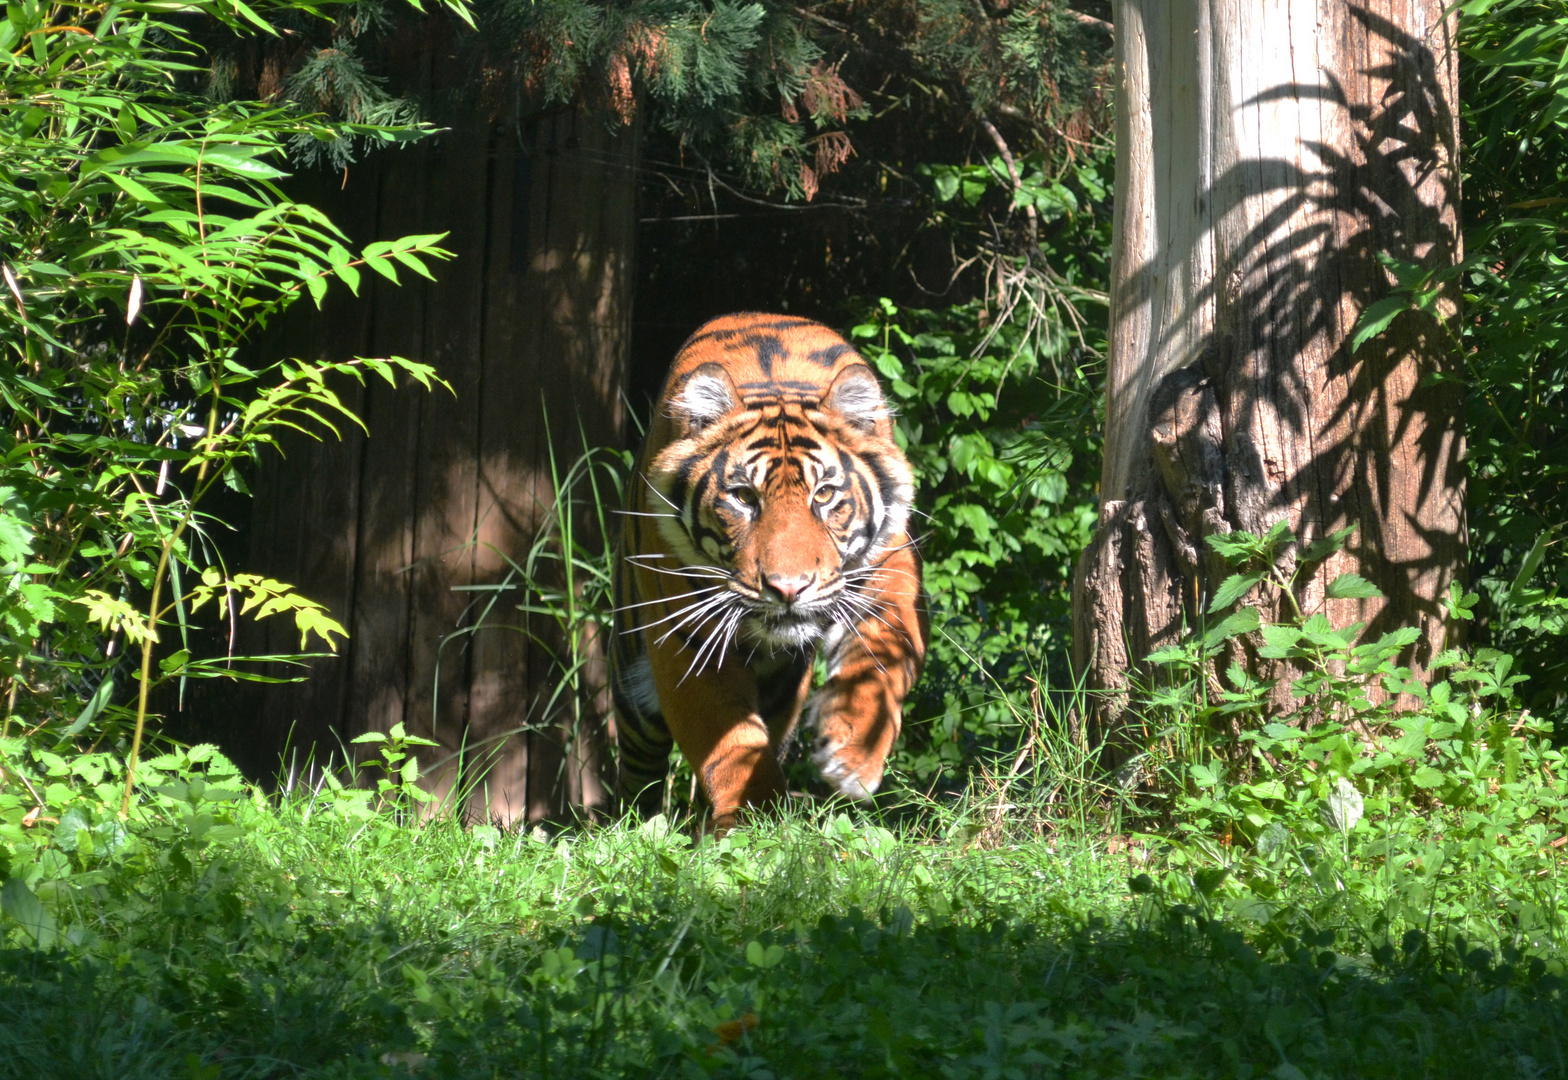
[1127,522,1568,873]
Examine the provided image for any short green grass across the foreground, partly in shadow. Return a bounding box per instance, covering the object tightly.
[0,774,1568,1080]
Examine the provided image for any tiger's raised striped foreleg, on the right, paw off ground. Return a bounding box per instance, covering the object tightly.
[806,541,927,799]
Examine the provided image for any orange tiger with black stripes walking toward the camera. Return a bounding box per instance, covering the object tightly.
[608,312,928,832]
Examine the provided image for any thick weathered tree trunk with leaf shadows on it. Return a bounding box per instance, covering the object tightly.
[1074,0,1465,734]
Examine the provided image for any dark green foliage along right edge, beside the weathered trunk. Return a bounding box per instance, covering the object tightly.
[1460,0,1568,730]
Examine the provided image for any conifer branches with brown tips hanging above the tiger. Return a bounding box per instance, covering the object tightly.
[464,0,1110,199]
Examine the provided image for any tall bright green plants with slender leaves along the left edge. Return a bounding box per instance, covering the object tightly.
[0,0,463,843]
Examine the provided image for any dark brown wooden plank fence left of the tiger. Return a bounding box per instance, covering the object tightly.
[189,110,637,824]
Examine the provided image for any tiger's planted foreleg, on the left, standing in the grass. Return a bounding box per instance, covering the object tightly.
[649,638,784,832]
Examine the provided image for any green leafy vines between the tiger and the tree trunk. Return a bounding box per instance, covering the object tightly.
[850,147,1109,787]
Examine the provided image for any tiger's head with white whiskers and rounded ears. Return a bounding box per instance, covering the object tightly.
[649,364,914,651]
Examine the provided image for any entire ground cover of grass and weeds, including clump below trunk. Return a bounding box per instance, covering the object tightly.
[0,517,1568,1080]
